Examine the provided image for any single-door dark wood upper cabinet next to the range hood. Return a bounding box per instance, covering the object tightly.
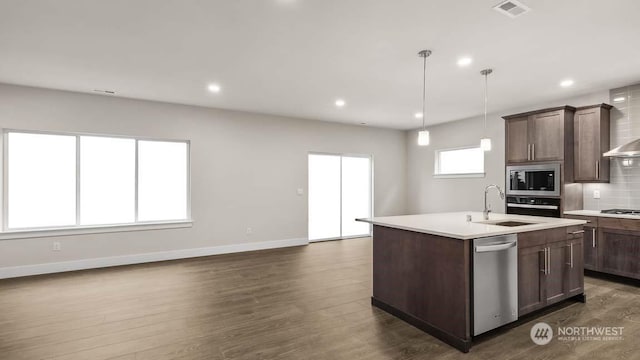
[573,104,612,182]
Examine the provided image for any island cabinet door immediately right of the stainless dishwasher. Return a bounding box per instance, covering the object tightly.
[518,245,545,316]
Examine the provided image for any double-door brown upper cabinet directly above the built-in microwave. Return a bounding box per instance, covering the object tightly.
[503,106,576,164]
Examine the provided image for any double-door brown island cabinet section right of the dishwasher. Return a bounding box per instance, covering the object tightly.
[518,226,584,316]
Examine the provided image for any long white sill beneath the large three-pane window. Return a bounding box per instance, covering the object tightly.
[0,220,193,240]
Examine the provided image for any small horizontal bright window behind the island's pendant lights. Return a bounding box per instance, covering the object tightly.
[434,147,484,177]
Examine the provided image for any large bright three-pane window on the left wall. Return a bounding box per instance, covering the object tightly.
[3,130,190,230]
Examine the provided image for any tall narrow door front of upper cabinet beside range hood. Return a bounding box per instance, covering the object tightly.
[573,107,608,181]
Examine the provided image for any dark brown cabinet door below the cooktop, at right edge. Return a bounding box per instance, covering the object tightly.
[598,228,640,279]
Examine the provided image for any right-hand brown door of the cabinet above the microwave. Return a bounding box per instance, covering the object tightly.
[529,111,564,161]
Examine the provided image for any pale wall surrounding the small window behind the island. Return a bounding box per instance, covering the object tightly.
[407,90,609,214]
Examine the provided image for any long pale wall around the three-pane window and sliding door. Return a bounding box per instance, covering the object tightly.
[0,84,407,268]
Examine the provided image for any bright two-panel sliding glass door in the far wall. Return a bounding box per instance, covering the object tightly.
[309,154,372,241]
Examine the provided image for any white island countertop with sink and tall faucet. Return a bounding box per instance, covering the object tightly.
[357,211,586,240]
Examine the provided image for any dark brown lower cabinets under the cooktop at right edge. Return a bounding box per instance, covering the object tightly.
[566,215,640,279]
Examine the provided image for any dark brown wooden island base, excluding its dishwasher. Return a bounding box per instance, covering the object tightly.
[364,222,585,352]
